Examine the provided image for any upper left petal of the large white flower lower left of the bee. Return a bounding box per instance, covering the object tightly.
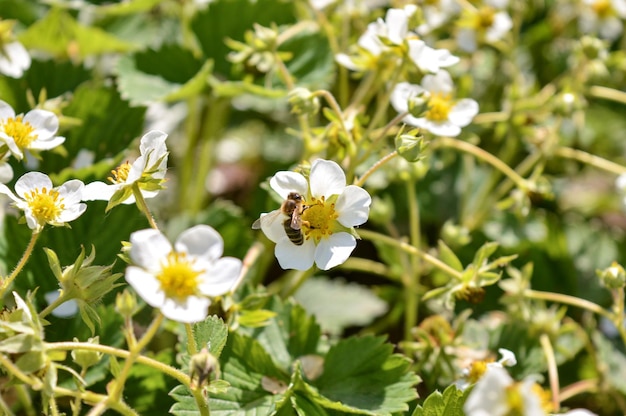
[130,228,172,272]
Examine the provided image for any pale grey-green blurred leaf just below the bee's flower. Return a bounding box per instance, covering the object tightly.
[294,277,388,335]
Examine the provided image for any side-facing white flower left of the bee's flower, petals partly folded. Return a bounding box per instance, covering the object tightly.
[83,130,168,210]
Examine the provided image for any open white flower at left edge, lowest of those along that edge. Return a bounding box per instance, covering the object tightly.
[0,172,87,232]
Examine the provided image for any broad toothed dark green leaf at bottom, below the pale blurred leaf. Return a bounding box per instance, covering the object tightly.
[314,336,419,415]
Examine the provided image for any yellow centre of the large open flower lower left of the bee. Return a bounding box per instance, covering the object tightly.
[157,252,201,301]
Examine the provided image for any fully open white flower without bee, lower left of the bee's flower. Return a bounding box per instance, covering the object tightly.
[126,225,241,323]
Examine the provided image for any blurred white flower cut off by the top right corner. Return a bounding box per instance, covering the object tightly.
[578,0,626,40]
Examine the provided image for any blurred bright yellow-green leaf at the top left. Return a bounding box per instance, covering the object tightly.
[20,8,136,58]
